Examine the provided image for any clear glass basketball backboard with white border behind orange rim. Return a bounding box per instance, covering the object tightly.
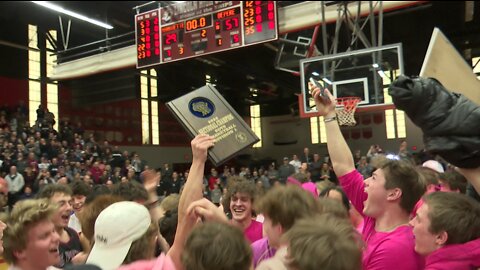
[299,43,404,117]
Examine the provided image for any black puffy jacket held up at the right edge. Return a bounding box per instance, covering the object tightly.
[388,76,480,168]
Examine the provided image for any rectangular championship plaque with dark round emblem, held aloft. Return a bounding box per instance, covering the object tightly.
[167,84,260,166]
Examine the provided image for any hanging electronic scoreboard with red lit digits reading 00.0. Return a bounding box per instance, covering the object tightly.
[135,1,278,68]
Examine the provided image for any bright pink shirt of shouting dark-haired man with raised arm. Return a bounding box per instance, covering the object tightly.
[338,170,424,270]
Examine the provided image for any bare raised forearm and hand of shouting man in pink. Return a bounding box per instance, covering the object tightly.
[309,83,355,177]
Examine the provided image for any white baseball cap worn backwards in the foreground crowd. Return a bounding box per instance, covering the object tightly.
[86,201,151,270]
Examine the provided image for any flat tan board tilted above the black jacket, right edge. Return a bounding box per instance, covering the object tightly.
[420,28,480,105]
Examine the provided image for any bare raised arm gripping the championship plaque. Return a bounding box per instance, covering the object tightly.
[168,134,215,270]
